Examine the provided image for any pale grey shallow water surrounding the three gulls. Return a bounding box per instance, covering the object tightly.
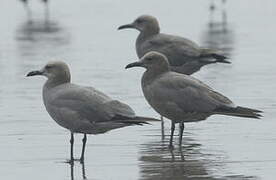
[0,0,276,180]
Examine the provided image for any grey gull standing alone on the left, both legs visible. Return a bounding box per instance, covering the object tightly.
[27,61,158,164]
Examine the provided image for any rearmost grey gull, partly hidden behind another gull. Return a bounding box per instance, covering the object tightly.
[118,15,230,75]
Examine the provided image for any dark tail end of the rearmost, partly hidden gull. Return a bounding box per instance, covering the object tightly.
[200,48,231,64]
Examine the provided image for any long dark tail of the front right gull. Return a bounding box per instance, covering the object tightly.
[217,106,263,119]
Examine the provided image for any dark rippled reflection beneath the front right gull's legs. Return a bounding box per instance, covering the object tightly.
[140,137,216,180]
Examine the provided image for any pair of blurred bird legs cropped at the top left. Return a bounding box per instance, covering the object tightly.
[20,0,50,23]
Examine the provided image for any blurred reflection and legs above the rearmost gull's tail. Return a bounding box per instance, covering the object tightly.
[202,0,235,56]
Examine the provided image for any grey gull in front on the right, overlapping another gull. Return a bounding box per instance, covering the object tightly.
[125,51,262,149]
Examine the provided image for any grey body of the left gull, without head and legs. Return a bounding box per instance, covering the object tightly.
[43,82,153,134]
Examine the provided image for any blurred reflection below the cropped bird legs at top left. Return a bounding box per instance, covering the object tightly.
[16,21,70,58]
